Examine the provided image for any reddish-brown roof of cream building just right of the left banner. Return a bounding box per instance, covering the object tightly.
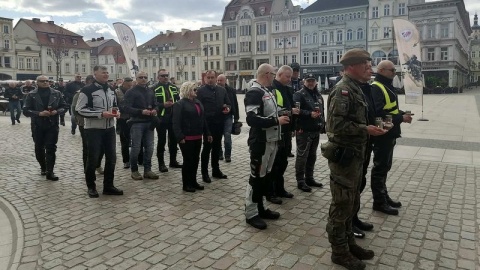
[138,30,200,53]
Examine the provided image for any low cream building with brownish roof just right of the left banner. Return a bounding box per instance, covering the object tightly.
[138,29,202,84]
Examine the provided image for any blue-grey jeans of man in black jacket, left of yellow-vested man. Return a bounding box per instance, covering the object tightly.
[130,122,154,172]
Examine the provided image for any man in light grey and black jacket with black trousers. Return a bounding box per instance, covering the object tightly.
[75,66,123,198]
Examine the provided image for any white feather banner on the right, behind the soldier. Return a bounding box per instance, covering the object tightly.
[393,19,423,105]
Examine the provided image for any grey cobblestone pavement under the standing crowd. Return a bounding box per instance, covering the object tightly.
[0,92,480,270]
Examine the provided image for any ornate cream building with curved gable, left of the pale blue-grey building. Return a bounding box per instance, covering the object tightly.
[222,0,300,86]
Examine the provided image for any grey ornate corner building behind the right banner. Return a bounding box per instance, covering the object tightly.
[408,0,472,88]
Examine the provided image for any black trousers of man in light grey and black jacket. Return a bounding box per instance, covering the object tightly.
[85,127,117,189]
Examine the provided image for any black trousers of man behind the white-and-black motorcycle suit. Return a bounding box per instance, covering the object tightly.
[267,138,292,196]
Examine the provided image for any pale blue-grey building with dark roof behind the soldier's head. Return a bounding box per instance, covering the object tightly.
[300,0,368,83]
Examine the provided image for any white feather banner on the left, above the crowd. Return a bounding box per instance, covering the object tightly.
[113,22,138,77]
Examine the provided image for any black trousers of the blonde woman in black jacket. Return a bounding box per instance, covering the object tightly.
[179,139,202,187]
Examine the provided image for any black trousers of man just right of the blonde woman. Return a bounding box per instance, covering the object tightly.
[202,123,223,175]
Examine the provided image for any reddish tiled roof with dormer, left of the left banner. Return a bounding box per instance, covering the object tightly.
[20,19,90,49]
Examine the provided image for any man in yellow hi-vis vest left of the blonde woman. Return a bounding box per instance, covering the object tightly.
[152,69,182,172]
